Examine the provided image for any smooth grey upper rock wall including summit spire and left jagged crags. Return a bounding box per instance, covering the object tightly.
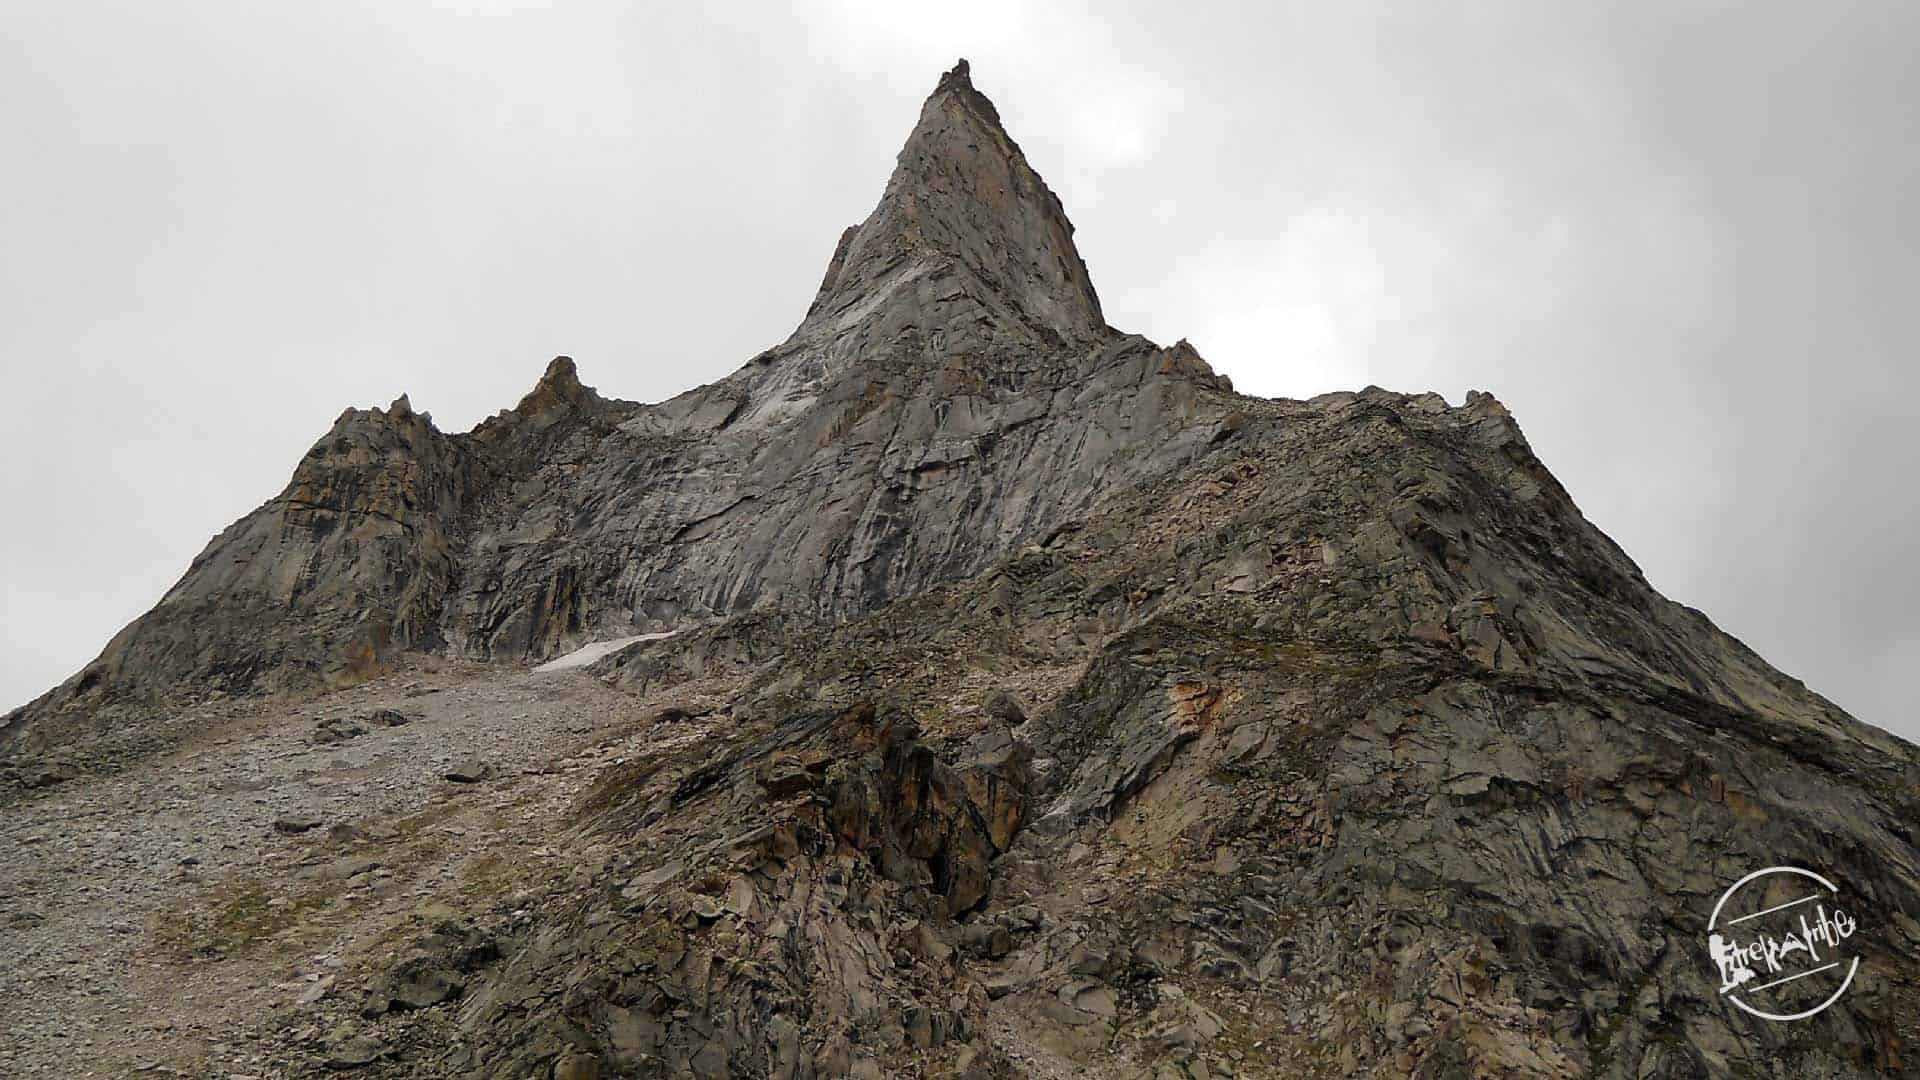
[4,61,1231,753]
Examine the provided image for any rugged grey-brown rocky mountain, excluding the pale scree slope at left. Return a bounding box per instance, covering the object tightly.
[6,63,1920,1080]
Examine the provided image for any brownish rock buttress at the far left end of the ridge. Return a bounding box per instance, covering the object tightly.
[13,398,474,723]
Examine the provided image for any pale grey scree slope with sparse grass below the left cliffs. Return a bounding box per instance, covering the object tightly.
[0,665,683,1078]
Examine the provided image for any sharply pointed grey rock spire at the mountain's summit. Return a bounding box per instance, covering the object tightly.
[797,60,1106,352]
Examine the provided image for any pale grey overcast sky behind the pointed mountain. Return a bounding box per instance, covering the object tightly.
[0,0,1920,738]
